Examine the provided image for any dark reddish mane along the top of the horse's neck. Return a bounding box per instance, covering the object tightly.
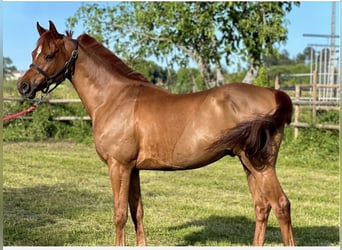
[77,34,148,82]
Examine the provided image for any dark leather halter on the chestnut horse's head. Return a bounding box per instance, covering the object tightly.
[30,40,78,94]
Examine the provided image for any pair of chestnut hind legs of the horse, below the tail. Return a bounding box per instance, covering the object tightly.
[240,156,295,246]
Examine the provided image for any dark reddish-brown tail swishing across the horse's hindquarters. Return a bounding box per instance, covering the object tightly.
[210,91,292,169]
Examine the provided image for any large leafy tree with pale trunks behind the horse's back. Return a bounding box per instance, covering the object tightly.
[68,1,299,88]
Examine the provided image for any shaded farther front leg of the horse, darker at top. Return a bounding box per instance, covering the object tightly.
[128,169,146,246]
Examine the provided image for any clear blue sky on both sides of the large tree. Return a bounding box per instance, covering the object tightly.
[2,1,341,70]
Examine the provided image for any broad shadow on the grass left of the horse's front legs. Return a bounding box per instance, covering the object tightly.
[3,184,112,246]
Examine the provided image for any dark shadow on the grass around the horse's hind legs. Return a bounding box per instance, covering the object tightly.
[169,216,339,246]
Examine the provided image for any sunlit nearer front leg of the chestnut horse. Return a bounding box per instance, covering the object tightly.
[108,159,131,246]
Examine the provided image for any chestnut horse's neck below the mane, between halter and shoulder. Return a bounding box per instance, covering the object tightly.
[72,48,127,119]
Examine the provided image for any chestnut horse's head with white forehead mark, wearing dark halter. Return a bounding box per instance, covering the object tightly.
[17,21,78,99]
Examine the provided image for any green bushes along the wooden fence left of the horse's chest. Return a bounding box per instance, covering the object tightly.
[3,99,92,142]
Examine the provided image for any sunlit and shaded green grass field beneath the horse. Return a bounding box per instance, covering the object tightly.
[3,139,340,246]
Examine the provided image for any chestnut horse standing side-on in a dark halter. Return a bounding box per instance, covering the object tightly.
[17,21,294,246]
